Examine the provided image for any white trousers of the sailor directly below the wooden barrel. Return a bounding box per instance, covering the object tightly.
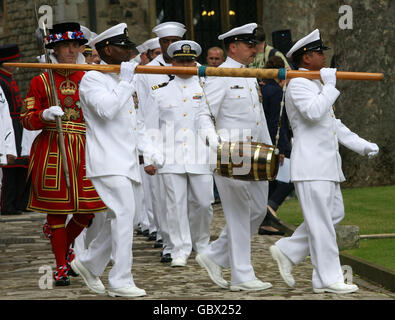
[204,173,269,284]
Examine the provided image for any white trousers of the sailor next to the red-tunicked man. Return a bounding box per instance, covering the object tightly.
[78,176,136,289]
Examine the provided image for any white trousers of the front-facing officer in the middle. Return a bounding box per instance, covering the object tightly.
[161,173,214,259]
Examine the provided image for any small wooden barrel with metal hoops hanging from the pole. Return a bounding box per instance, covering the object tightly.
[216,141,279,181]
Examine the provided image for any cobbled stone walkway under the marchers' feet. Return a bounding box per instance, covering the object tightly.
[0,205,395,300]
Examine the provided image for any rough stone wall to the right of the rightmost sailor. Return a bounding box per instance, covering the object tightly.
[335,0,395,186]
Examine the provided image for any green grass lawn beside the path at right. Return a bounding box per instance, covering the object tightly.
[278,185,395,270]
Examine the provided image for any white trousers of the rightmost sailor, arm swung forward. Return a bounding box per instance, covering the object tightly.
[276,181,344,289]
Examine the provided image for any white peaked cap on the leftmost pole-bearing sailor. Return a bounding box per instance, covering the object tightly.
[91,23,135,49]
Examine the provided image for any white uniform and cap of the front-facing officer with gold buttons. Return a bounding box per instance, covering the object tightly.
[153,40,214,263]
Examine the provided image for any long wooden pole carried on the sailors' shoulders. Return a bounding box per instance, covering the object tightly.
[4,62,384,81]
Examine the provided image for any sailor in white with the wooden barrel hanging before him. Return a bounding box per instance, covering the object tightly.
[196,23,272,291]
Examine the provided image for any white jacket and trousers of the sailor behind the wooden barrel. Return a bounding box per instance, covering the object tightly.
[198,57,272,284]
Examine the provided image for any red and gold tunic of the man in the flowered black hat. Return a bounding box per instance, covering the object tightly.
[21,70,106,214]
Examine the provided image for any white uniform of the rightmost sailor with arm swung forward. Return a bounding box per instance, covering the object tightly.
[276,30,378,289]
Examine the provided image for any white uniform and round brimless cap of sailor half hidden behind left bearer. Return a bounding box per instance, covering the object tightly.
[135,22,186,255]
